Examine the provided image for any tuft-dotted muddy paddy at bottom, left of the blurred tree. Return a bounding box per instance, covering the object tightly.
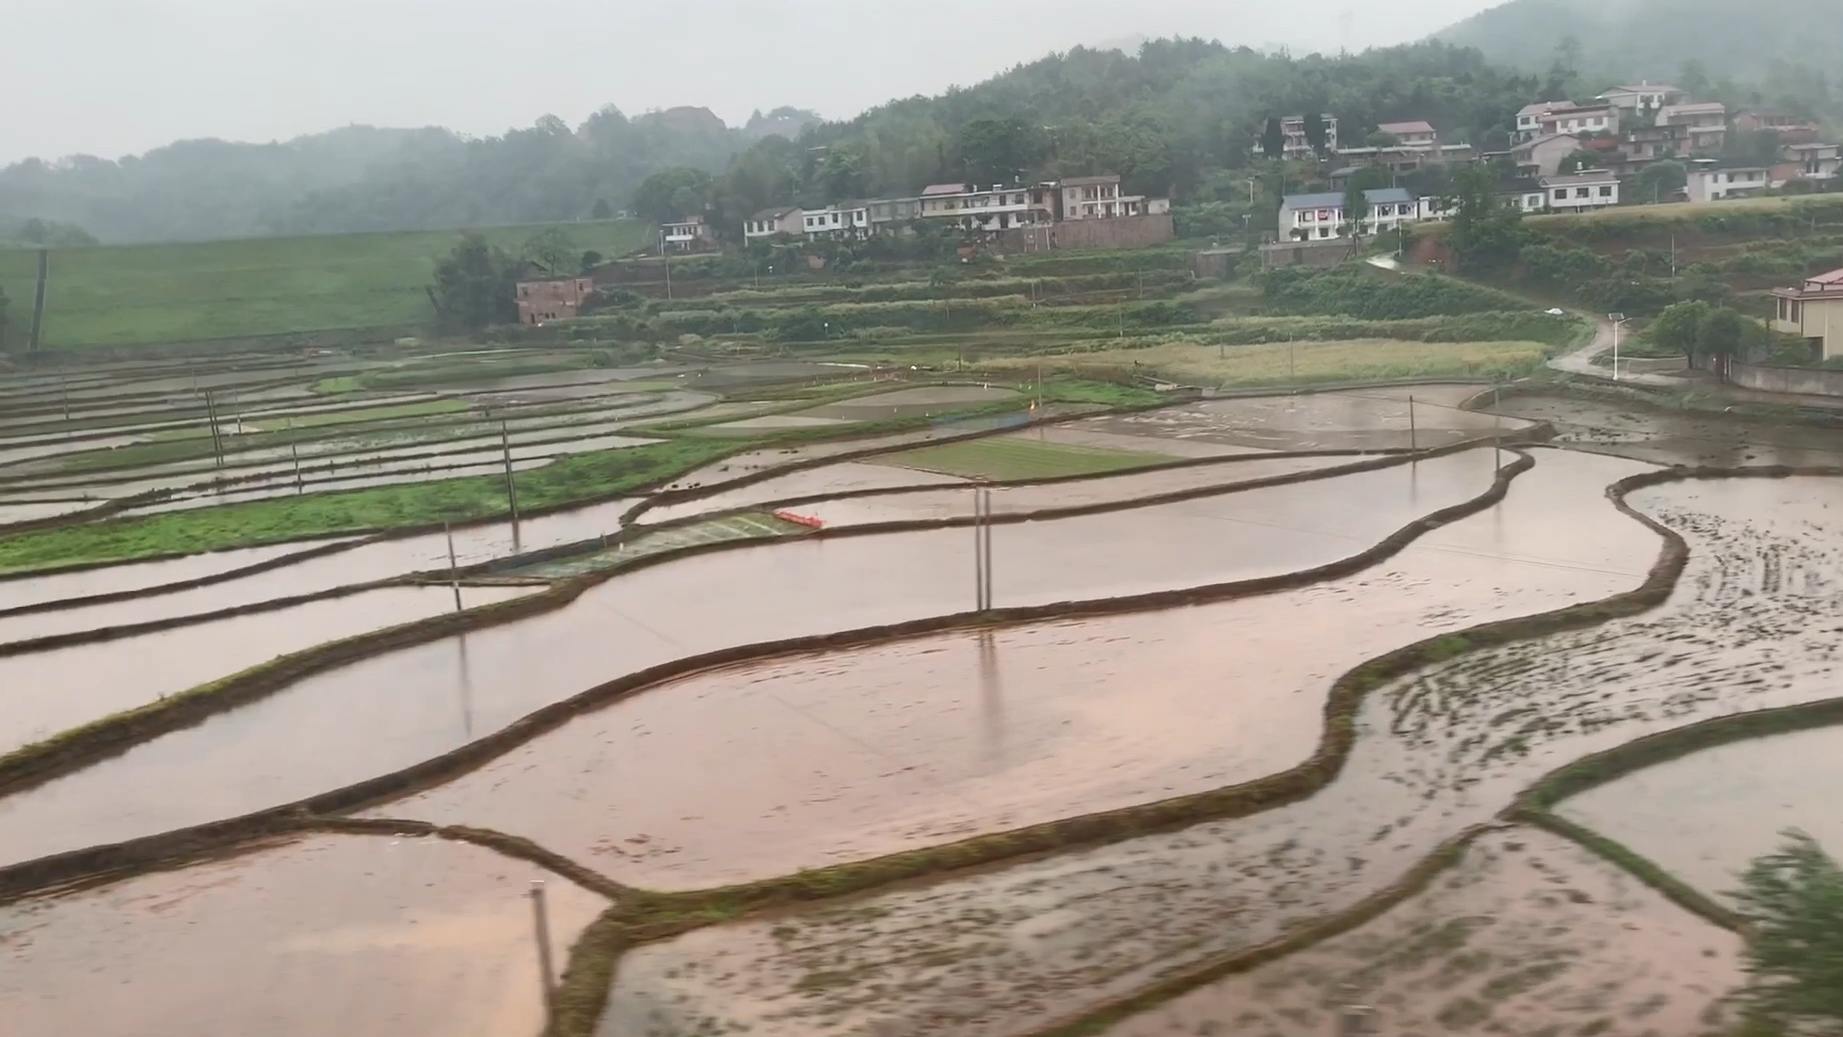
[1105,829,1743,1037]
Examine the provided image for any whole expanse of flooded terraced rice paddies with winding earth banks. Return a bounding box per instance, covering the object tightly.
[0,354,1843,1037]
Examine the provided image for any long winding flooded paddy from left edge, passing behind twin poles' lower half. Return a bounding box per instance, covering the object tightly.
[0,449,1493,862]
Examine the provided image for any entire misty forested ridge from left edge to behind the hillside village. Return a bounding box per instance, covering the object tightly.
[0,41,1544,241]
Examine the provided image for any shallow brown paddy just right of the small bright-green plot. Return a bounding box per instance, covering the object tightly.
[1062,385,1522,449]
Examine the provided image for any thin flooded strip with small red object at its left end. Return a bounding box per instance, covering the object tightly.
[792,457,1356,527]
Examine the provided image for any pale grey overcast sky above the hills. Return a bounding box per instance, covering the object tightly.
[0,0,1497,162]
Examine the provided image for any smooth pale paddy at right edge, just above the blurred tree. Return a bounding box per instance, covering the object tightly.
[1559,728,1843,899]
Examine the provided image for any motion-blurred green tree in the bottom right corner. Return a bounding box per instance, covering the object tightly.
[1734,833,1843,1035]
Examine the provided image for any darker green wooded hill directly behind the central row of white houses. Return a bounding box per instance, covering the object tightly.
[670,41,1543,233]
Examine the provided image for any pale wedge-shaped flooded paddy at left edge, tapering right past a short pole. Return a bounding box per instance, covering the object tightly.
[0,588,542,753]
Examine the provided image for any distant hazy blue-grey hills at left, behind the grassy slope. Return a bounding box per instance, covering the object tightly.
[0,107,816,241]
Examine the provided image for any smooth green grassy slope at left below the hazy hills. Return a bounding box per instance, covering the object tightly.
[0,221,647,348]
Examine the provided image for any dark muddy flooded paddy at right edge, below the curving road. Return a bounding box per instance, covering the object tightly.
[1500,394,1843,468]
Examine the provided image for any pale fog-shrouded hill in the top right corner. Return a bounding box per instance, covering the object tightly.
[1436,0,1843,112]
